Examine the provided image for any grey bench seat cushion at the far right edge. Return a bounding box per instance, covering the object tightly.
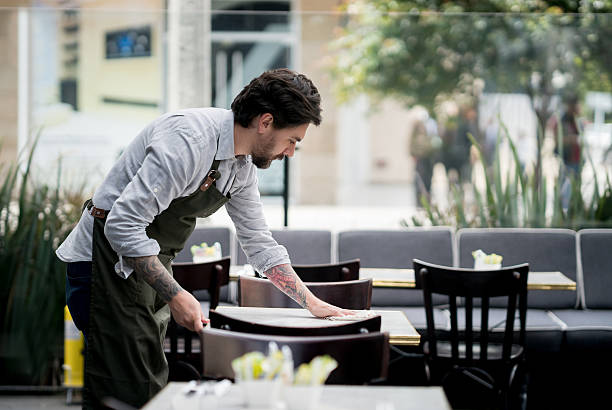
[552,309,612,352]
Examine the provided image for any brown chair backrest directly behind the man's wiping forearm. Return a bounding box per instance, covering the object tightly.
[238,276,372,309]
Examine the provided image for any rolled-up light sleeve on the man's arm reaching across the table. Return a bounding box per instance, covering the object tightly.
[225,166,291,273]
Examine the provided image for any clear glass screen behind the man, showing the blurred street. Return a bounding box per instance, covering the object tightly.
[0,1,612,230]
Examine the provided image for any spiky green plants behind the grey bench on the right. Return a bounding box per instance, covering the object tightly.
[401,121,612,230]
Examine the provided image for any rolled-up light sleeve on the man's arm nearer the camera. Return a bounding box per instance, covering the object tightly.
[104,128,204,260]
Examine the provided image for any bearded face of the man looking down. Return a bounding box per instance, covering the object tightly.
[251,122,309,169]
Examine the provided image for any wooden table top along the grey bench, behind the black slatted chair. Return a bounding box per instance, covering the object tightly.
[230,265,576,290]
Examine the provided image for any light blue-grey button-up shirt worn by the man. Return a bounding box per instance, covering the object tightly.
[56,108,290,277]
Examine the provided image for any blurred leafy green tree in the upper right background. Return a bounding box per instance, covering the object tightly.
[332,0,612,179]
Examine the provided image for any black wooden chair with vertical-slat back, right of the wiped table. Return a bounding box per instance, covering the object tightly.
[414,259,529,408]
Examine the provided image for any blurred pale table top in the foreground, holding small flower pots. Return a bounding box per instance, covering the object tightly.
[143,382,451,410]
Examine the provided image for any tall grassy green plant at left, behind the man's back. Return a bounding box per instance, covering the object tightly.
[0,138,82,384]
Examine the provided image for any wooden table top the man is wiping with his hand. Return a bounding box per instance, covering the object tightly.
[216,306,421,346]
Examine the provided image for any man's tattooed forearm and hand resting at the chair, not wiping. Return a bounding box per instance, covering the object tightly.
[123,256,208,332]
